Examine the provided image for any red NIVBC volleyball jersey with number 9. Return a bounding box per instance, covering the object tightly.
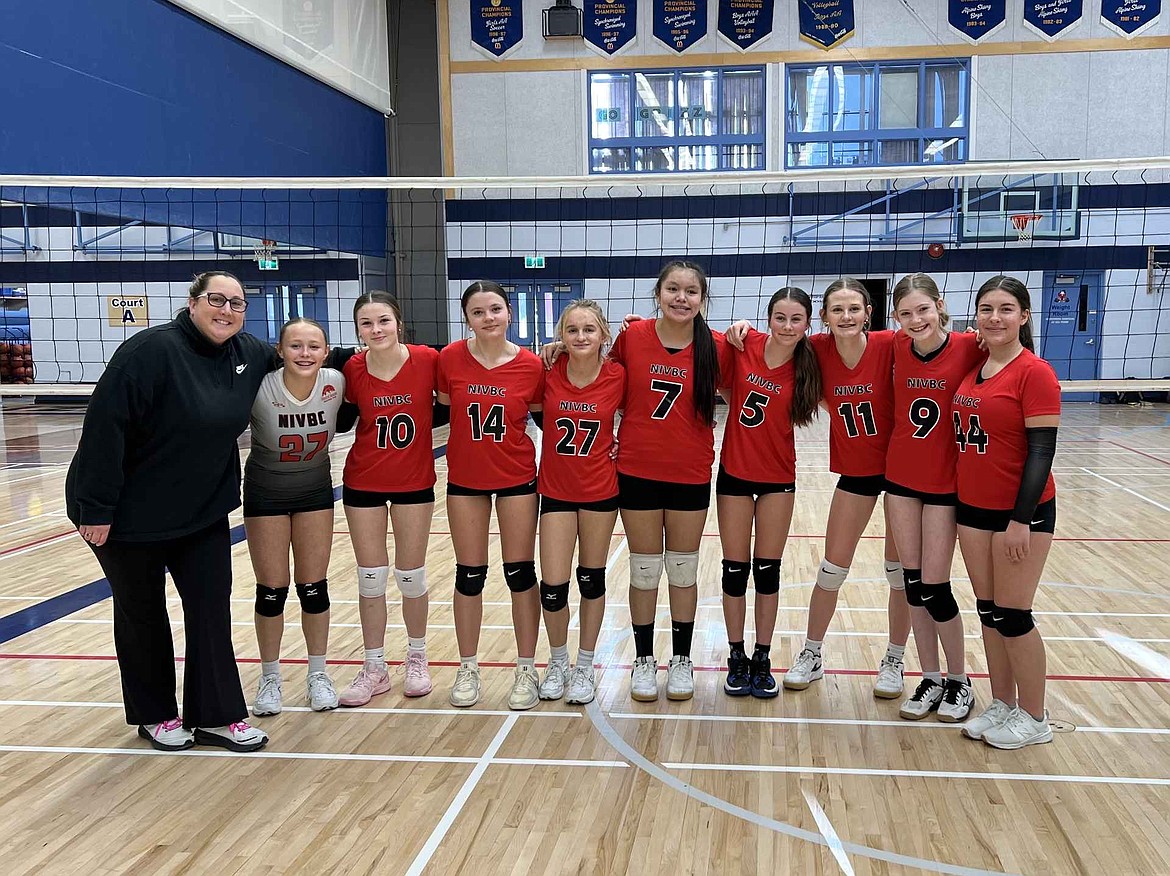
[886,332,987,492]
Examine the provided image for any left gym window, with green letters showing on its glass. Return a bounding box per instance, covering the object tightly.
[589,67,765,173]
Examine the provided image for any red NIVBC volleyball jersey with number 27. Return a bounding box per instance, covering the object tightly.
[541,356,626,502]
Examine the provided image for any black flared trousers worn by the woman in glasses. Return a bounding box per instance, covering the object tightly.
[94,518,248,727]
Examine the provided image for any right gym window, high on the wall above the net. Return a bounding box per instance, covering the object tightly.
[785,61,970,167]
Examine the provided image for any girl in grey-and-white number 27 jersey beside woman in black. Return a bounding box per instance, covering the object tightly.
[243,317,345,716]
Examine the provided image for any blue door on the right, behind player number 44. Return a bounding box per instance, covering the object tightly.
[1032,271,1104,401]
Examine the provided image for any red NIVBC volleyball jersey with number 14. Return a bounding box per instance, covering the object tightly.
[439,340,544,490]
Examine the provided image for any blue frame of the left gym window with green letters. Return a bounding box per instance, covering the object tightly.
[585,64,769,177]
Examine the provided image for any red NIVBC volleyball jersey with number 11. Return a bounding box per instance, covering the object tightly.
[808,331,894,477]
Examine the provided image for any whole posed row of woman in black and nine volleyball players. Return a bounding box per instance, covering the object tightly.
[66,260,1060,751]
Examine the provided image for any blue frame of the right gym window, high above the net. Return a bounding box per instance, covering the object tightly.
[783,57,971,170]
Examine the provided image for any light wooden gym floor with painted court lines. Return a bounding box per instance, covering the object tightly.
[0,399,1170,876]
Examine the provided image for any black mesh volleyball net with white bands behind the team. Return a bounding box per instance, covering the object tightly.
[0,158,1170,400]
